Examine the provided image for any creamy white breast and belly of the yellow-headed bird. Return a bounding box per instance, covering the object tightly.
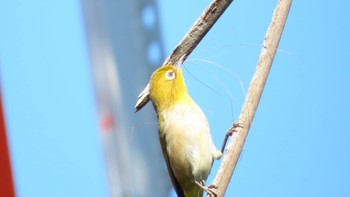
[159,103,213,180]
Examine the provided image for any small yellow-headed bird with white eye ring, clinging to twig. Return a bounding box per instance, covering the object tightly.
[136,56,222,197]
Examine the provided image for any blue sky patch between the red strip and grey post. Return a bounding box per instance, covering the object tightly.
[0,1,107,196]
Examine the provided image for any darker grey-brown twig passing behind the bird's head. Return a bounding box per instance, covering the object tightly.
[135,0,233,111]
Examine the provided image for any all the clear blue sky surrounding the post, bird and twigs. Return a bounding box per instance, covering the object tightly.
[0,0,350,196]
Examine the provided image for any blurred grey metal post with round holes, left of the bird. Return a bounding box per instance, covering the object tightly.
[83,0,170,196]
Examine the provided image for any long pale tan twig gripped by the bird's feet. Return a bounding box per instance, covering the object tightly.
[212,0,292,197]
